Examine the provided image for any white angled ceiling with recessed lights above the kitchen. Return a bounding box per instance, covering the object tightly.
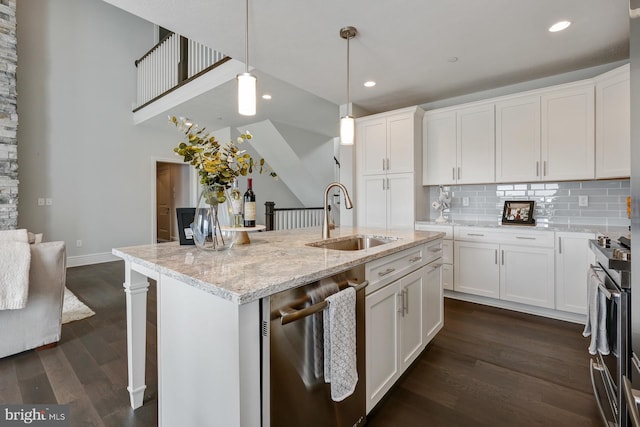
[105,0,629,134]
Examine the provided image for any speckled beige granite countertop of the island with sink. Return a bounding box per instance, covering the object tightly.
[112,227,444,304]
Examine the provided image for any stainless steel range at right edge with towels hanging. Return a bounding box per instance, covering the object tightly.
[585,236,631,427]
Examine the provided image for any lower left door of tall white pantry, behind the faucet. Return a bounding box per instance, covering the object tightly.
[356,175,387,231]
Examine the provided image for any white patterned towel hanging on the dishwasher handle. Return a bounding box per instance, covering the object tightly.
[323,287,358,402]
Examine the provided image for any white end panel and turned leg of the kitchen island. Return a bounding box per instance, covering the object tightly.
[124,261,260,427]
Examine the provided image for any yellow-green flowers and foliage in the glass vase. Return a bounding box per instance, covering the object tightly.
[169,116,277,203]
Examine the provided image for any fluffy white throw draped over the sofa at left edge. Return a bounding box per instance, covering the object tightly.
[0,229,31,310]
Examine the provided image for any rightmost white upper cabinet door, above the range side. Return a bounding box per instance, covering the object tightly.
[595,64,631,179]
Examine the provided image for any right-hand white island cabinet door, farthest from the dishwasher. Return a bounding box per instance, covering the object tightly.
[422,262,442,346]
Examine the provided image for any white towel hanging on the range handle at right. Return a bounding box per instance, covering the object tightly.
[582,268,609,355]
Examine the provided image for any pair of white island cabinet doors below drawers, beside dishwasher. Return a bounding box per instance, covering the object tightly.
[365,261,444,413]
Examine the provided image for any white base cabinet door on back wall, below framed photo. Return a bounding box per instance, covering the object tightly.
[500,245,555,308]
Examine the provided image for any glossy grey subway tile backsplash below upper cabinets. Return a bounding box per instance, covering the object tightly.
[426,179,630,226]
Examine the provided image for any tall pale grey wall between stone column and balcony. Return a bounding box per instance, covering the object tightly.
[17,0,186,265]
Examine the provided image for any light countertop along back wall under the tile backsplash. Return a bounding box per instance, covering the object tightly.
[416,220,629,239]
